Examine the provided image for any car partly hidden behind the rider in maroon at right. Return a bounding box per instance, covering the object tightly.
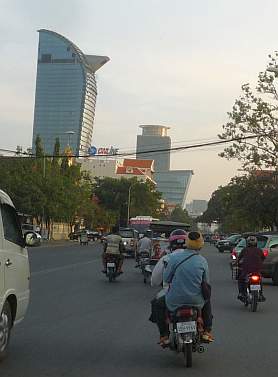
[231,233,278,285]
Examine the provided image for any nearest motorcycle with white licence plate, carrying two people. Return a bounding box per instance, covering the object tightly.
[169,306,208,368]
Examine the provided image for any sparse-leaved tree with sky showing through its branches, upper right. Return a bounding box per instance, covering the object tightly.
[219,53,278,169]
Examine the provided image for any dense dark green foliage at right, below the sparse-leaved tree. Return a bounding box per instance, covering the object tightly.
[200,174,278,232]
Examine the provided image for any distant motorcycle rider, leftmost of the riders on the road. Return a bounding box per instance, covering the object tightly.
[102,225,124,274]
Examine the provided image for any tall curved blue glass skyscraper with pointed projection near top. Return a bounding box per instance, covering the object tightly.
[33,29,109,155]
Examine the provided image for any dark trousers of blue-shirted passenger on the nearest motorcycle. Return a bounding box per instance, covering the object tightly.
[150,296,213,336]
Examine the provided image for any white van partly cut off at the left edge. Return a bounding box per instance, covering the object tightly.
[0,190,33,361]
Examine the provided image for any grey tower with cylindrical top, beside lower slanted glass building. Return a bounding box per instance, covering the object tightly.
[136,125,171,172]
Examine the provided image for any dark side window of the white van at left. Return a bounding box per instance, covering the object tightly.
[1,204,23,246]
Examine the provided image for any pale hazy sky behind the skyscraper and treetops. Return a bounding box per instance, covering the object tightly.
[0,0,278,200]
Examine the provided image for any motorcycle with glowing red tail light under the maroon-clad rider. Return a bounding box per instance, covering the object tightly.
[243,273,265,312]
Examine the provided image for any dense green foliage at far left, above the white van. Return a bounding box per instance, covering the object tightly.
[0,157,93,234]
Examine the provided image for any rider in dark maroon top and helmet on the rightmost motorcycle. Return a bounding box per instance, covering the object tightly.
[238,236,265,301]
